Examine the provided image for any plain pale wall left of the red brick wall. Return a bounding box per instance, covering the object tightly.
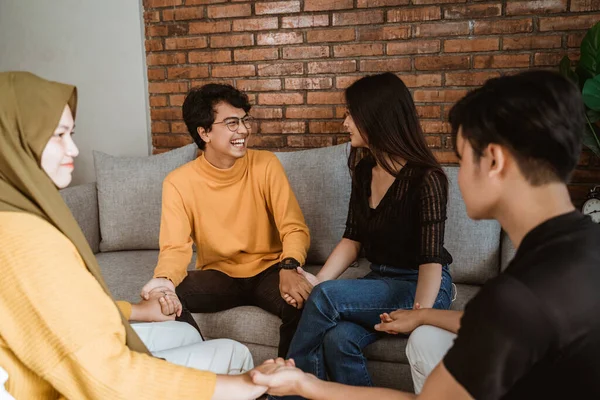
[0,0,151,184]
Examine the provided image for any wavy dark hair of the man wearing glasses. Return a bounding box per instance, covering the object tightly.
[183,83,252,149]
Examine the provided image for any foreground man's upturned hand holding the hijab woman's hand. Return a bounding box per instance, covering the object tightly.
[250,358,308,396]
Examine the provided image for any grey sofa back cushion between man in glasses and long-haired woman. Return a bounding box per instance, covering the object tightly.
[275,144,351,264]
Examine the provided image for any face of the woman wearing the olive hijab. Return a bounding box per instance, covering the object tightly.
[41,106,79,189]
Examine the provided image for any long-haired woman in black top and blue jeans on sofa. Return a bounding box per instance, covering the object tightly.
[287,73,452,386]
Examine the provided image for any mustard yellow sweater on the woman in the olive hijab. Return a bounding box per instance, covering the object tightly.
[0,212,216,399]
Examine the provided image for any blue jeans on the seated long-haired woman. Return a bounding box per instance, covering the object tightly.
[288,264,452,396]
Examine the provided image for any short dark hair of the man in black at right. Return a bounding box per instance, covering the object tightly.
[450,71,585,186]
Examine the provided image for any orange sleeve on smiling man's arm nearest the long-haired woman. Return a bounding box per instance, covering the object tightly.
[266,155,310,265]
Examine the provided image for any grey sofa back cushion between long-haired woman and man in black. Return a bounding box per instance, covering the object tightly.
[444,167,500,285]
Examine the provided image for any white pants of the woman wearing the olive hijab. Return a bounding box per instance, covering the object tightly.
[131,321,254,375]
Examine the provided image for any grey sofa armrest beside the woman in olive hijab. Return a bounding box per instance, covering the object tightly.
[60,182,100,254]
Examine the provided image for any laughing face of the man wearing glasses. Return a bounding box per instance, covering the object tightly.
[198,102,252,168]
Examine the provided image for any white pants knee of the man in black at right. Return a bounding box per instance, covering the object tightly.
[406,325,456,394]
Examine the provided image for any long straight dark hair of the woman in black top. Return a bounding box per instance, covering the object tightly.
[346,72,442,181]
